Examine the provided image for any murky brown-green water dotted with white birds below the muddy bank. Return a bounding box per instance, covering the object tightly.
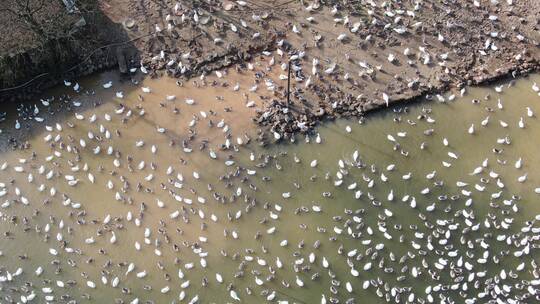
[0,73,540,303]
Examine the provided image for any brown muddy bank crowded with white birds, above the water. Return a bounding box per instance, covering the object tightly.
[4,0,540,141]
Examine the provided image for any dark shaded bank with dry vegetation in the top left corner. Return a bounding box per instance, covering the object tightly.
[0,0,139,100]
